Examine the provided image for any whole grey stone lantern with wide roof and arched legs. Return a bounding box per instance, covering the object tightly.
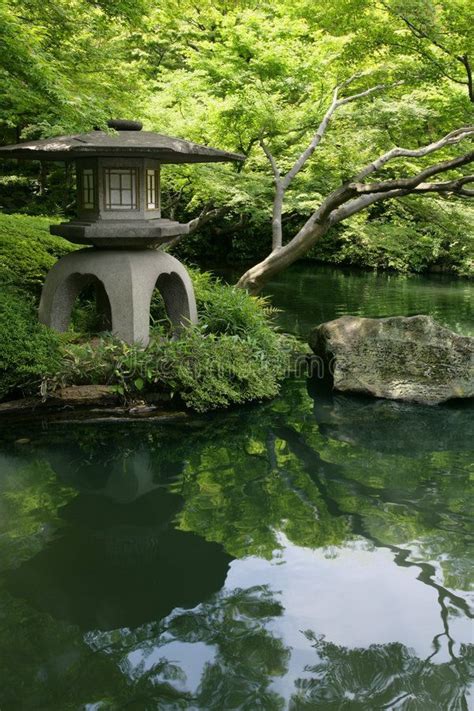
[0,120,244,346]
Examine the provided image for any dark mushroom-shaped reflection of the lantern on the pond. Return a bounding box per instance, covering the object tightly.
[6,488,232,630]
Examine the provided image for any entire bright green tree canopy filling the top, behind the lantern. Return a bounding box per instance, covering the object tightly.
[0,0,473,272]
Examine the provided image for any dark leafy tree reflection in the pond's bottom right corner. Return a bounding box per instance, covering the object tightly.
[289,632,474,711]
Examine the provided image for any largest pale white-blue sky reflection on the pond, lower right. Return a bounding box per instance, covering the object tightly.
[232,540,473,696]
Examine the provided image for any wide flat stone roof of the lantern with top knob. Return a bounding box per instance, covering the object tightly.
[0,120,245,163]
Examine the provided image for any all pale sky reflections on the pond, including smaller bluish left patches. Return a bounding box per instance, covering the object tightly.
[82,534,473,711]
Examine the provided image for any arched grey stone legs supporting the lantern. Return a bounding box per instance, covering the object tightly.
[39,248,197,346]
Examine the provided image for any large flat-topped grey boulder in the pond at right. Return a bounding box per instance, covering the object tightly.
[309,316,474,405]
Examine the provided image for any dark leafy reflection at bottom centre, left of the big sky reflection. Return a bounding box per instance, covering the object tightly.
[110,587,290,711]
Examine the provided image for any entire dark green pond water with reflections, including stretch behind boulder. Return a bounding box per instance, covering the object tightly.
[0,267,474,711]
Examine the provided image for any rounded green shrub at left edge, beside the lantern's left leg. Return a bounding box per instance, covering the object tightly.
[0,289,61,399]
